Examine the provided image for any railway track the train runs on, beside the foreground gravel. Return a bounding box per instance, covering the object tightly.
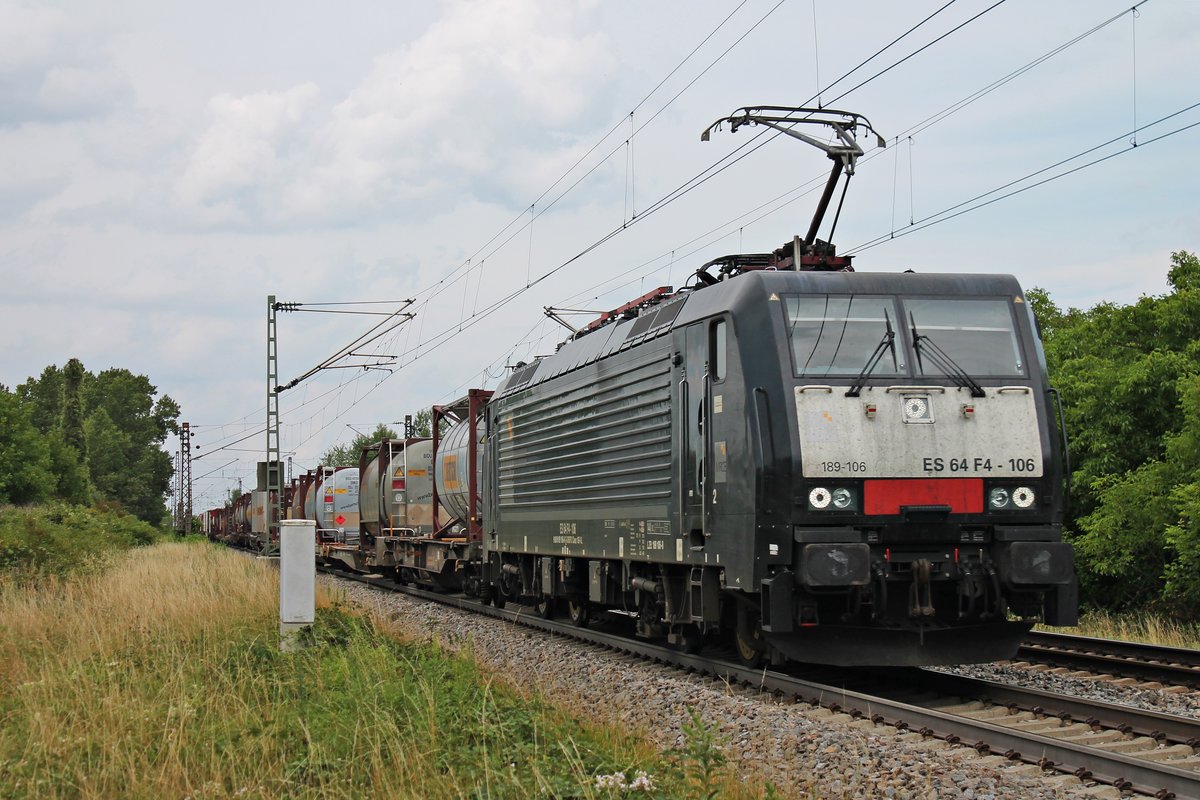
[307,570,1200,800]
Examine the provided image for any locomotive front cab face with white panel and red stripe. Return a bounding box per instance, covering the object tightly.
[713,272,1075,664]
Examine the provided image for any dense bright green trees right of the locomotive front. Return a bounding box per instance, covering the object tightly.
[1030,252,1200,613]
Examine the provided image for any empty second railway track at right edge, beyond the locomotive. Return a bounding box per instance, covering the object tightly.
[1014,632,1200,688]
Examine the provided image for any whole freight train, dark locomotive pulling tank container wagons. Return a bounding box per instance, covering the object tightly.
[205,107,1078,666]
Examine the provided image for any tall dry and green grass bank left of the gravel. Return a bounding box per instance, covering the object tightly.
[0,542,761,800]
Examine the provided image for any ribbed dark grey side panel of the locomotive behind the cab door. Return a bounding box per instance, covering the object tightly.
[488,337,685,561]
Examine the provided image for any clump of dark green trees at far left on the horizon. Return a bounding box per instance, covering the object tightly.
[17,359,179,524]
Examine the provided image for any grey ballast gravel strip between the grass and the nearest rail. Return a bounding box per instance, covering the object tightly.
[322,576,1137,800]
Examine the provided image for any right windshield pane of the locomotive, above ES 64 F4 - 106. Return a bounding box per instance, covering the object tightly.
[904,297,1026,377]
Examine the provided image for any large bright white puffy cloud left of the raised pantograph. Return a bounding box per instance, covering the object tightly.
[176,0,607,224]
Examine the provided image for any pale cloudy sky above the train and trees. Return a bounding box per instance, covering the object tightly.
[0,0,1200,509]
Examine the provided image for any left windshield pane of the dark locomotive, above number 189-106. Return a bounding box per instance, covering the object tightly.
[784,295,904,378]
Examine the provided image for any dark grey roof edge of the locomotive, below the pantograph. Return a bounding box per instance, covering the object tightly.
[496,270,1021,398]
